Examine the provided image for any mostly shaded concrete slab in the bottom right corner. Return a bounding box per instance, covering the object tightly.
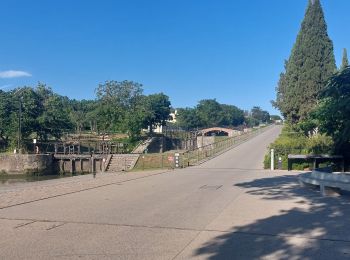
[177,231,350,260]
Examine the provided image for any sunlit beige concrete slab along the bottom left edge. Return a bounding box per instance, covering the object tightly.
[0,218,198,259]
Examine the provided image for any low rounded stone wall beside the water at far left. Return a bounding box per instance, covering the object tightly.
[0,154,56,174]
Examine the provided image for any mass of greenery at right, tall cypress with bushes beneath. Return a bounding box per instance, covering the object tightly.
[265,0,350,168]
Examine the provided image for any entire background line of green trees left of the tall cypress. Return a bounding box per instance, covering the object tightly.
[0,81,270,150]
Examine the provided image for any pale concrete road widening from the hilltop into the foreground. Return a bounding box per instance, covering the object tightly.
[0,127,350,259]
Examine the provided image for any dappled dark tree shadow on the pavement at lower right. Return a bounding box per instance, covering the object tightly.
[195,175,350,259]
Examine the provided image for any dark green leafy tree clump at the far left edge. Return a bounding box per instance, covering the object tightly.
[0,83,74,147]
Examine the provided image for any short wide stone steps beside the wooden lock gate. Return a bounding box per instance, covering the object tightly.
[106,154,140,172]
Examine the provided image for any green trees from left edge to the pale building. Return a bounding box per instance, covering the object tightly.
[0,81,171,149]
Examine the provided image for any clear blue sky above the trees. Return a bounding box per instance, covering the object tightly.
[0,0,350,113]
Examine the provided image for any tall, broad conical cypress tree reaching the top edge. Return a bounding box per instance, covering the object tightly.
[273,0,336,123]
